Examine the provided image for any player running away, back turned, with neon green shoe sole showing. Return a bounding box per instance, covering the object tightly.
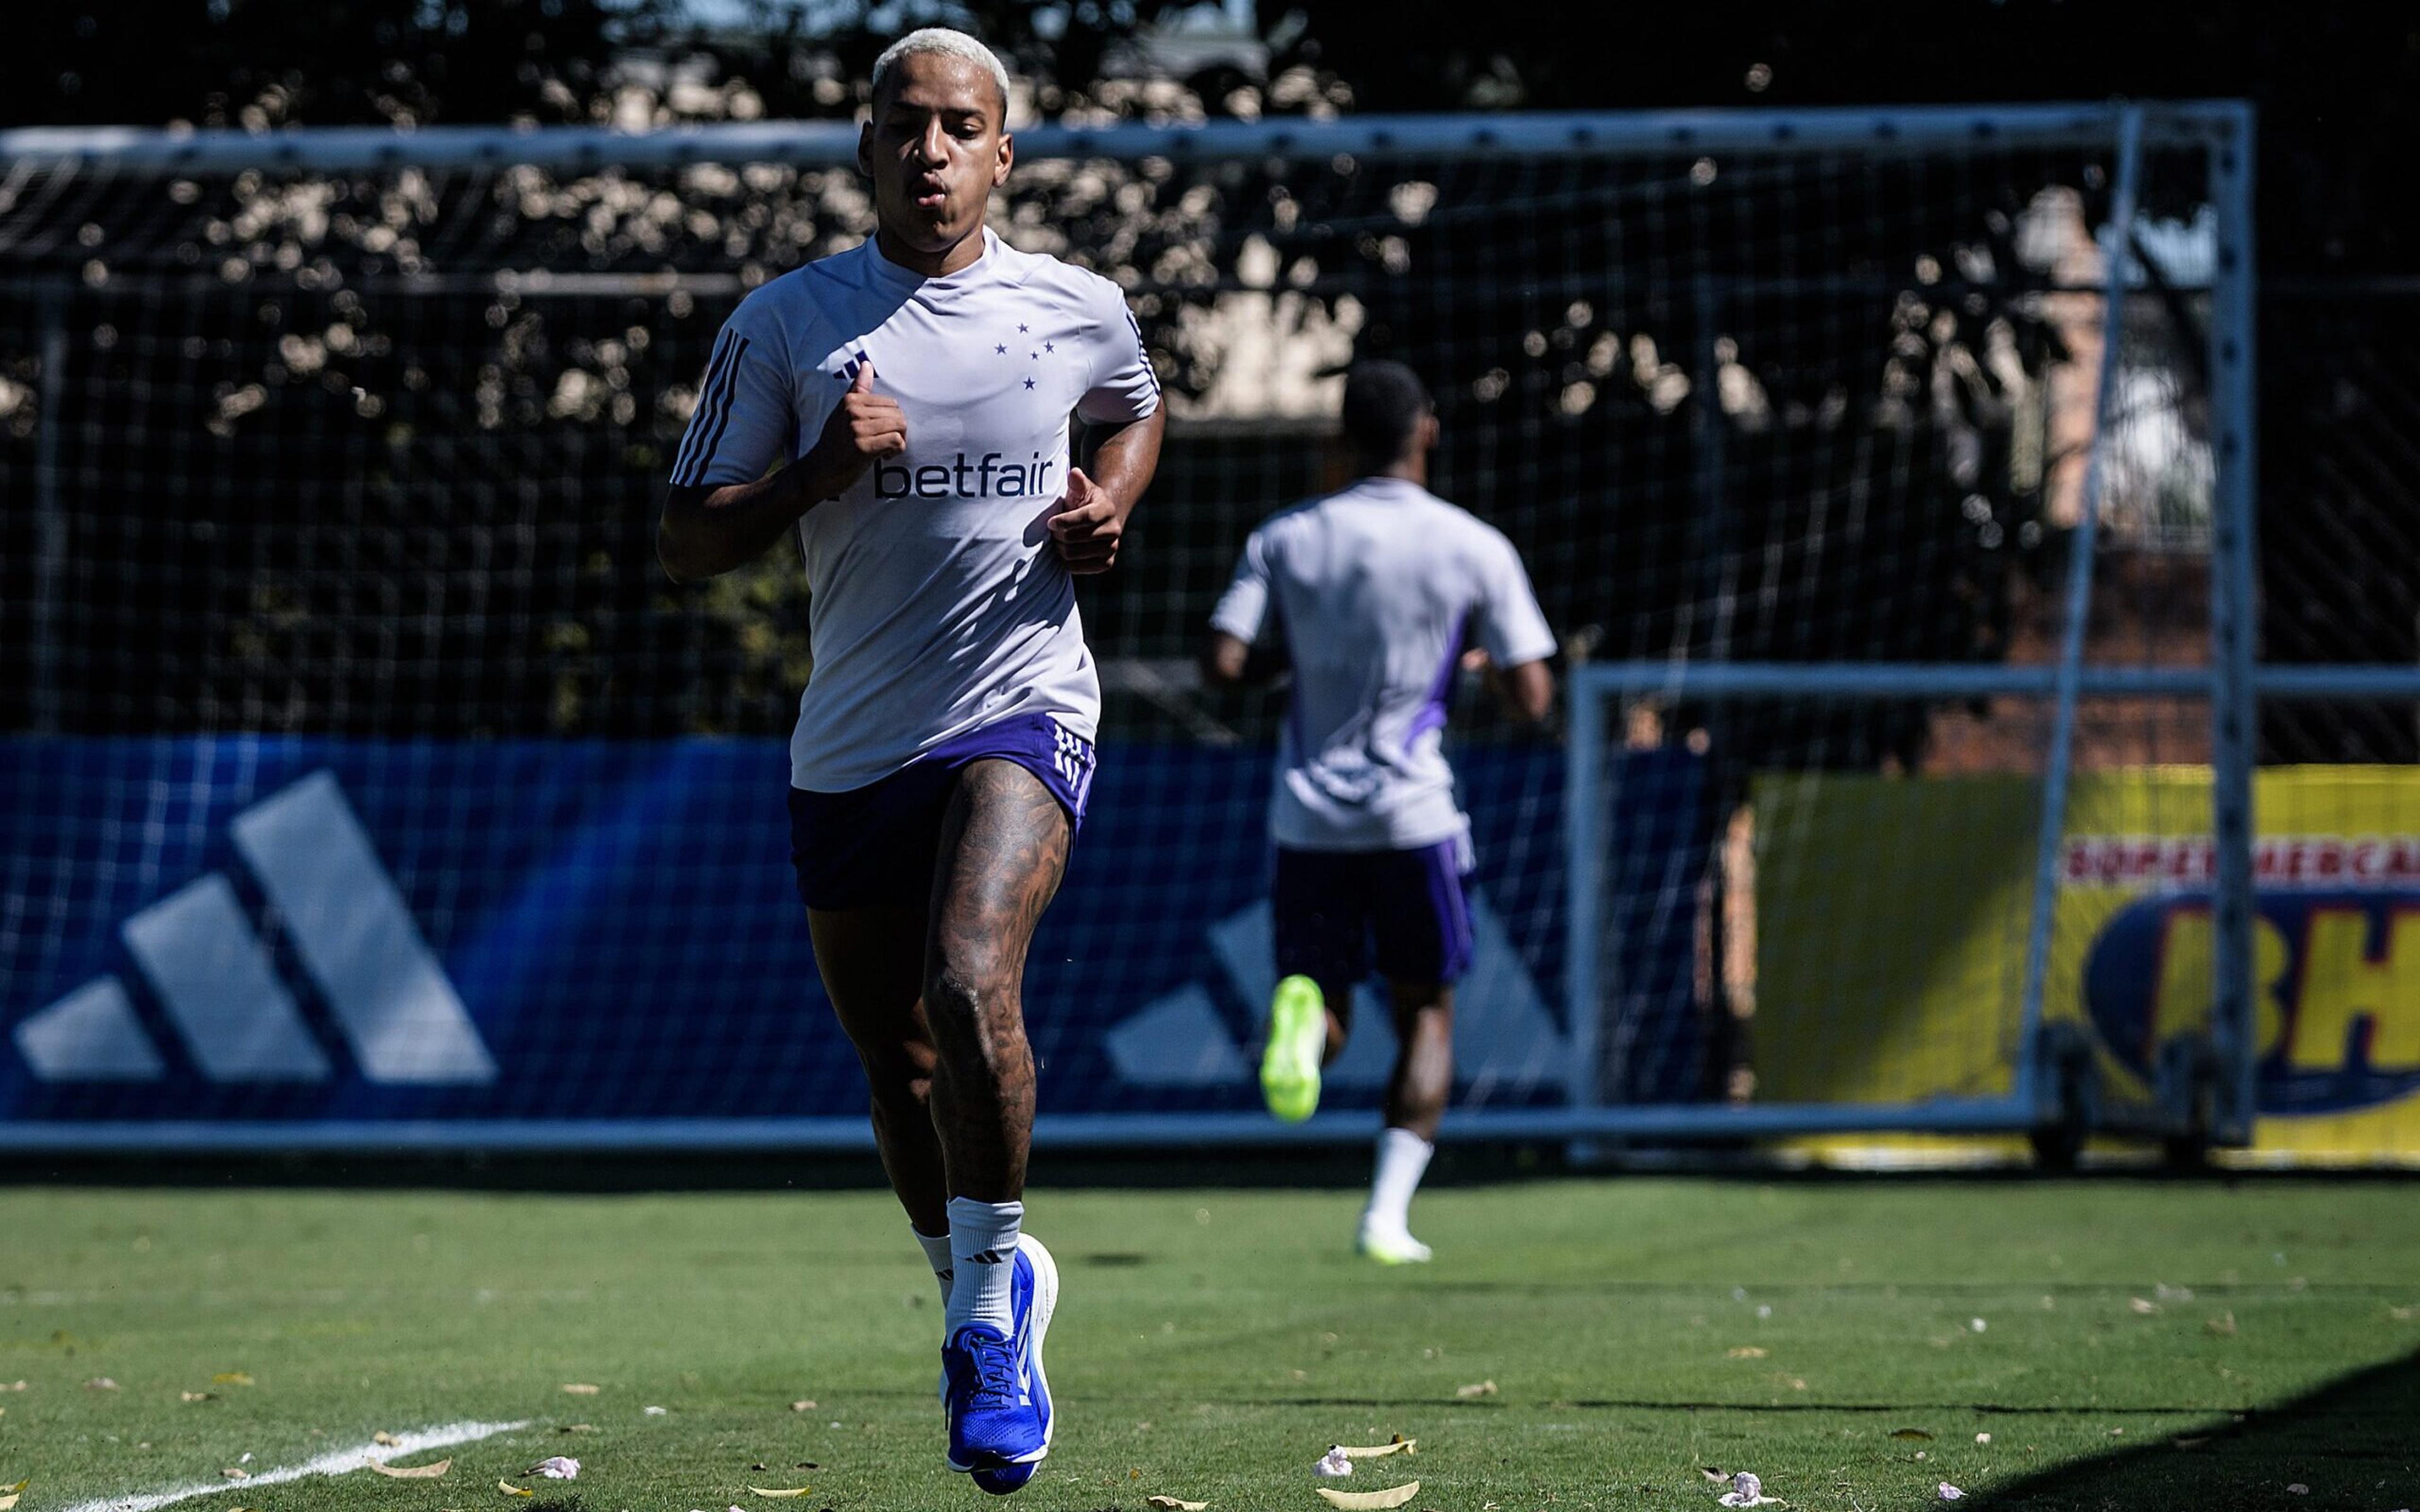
[1202,363,1553,1265]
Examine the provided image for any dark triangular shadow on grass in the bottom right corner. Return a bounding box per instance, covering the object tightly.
[1974,1353,2420,1512]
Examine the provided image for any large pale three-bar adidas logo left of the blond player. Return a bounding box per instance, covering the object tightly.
[14,772,496,1086]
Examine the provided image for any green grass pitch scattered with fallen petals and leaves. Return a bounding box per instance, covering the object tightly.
[0,1178,2420,1512]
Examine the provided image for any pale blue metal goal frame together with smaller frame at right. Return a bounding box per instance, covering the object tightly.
[0,101,2323,1152]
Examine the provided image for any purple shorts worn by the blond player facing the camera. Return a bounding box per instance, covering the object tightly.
[789,714,1094,910]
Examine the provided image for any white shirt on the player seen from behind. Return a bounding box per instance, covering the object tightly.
[1210,476,1553,852]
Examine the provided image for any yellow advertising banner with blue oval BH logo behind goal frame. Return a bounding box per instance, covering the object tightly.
[1754,767,2420,1164]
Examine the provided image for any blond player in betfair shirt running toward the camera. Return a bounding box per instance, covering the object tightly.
[658,29,1164,1495]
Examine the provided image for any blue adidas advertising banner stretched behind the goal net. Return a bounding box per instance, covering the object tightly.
[0,735,1645,1144]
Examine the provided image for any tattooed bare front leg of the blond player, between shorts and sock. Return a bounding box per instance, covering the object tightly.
[925,760,1069,1202]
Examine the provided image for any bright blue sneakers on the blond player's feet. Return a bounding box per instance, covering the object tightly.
[942,1236,1057,1495]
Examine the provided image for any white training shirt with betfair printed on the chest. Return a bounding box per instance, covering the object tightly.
[673,230,1159,794]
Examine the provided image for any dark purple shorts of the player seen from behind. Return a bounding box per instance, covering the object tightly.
[1268,839,1472,985]
